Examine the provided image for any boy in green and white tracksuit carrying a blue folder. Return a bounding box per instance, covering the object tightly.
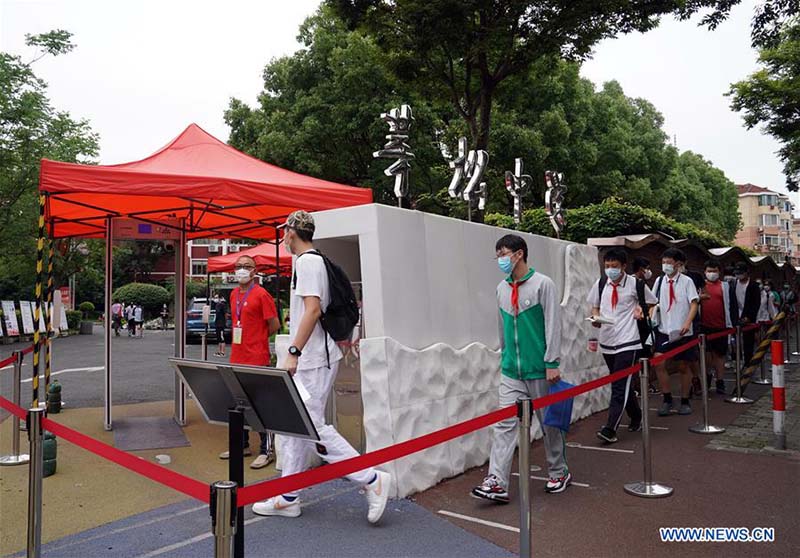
[472,234,572,504]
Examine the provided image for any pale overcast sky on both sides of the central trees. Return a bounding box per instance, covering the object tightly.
[0,0,797,201]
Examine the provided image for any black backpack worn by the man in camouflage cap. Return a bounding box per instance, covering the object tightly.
[292,250,359,348]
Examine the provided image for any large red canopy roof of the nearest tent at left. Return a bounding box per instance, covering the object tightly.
[39,124,372,239]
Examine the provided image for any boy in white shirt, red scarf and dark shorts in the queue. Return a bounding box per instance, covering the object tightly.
[651,248,700,417]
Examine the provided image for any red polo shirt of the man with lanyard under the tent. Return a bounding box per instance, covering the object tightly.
[230,284,278,366]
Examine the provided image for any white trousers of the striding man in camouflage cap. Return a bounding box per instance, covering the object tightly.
[281,362,375,496]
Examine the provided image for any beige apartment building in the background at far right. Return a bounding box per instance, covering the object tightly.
[735,184,800,263]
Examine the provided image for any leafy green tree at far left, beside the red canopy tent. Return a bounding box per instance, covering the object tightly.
[0,30,98,298]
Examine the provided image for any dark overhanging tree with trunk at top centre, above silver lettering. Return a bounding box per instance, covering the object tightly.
[327,0,738,149]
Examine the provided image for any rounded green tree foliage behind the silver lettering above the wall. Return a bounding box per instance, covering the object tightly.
[225,6,739,240]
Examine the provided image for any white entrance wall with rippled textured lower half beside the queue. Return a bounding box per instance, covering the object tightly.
[277,205,609,497]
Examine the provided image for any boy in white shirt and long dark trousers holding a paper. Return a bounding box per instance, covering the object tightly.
[588,248,658,444]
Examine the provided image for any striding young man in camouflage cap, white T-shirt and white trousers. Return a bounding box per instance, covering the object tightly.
[248,211,392,523]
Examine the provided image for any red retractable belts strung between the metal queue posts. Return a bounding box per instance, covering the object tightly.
[0,324,780,507]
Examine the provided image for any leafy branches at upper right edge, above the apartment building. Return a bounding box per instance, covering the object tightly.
[728,16,800,192]
